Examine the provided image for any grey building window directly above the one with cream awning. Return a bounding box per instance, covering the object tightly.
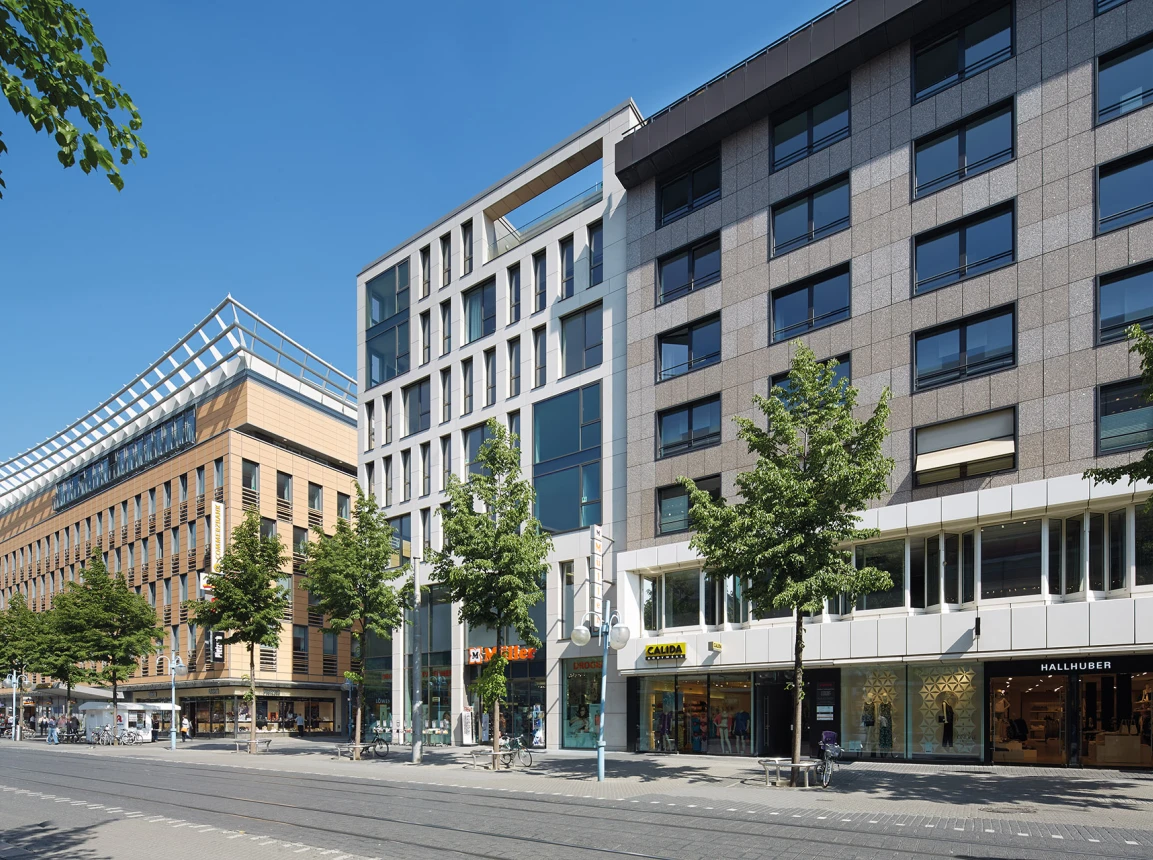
[914,308,1017,390]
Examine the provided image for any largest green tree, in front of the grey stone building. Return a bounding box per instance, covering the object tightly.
[679,342,892,779]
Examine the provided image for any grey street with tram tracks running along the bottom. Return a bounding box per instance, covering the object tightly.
[0,745,1153,860]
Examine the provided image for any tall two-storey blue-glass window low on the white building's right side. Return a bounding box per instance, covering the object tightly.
[533,383,601,531]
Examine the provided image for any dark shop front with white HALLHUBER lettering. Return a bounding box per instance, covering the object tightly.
[986,655,1153,768]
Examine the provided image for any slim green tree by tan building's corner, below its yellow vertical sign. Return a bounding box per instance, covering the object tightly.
[189,510,292,753]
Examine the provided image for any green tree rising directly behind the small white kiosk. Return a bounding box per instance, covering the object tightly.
[68,552,164,726]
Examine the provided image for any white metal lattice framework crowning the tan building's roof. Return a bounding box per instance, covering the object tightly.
[0,295,356,511]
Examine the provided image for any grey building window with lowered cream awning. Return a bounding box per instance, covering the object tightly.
[913,408,1017,486]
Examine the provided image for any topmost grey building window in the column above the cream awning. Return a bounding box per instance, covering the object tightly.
[913,6,1012,100]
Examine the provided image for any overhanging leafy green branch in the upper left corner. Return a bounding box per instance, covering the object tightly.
[0,0,148,196]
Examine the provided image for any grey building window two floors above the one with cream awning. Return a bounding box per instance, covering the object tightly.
[913,205,1017,293]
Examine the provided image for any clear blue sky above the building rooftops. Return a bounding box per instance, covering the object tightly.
[0,0,827,459]
